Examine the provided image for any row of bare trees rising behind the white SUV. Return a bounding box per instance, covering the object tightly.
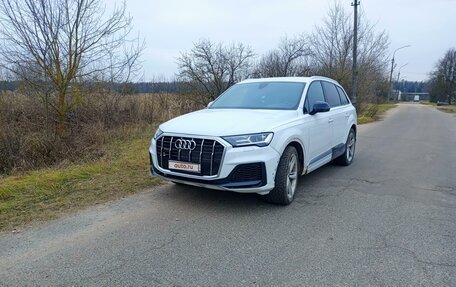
[177,2,389,105]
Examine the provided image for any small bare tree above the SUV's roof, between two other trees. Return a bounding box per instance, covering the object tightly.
[253,35,311,77]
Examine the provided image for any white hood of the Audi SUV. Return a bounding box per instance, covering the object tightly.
[160,109,297,136]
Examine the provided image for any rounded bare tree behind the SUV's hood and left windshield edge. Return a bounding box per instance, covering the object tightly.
[177,40,255,105]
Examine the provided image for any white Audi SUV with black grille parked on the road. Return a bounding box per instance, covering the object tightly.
[149,77,356,204]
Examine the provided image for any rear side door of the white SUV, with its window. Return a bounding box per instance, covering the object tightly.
[322,81,347,154]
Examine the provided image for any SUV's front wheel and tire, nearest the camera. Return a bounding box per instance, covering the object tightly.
[265,146,300,205]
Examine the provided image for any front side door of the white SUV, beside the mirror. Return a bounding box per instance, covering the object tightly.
[304,81,332,172]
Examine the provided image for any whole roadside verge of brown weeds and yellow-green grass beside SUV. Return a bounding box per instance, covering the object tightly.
[0,93,201,233]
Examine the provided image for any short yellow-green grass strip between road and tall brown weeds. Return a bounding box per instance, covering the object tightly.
[0,127,161,233]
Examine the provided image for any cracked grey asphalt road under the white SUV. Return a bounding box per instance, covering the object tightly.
[0,104,456,286]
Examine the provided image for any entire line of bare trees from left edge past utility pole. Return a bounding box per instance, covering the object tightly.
[0,0,389,140]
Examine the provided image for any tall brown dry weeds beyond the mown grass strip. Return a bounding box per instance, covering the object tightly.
[0,93,201,174]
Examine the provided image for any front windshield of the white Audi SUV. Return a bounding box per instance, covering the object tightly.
[210,82,306,110]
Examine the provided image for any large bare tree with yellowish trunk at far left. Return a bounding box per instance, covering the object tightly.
[0,0,143,137]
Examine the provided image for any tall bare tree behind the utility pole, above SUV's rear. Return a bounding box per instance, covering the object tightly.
[310,2,389,103]
